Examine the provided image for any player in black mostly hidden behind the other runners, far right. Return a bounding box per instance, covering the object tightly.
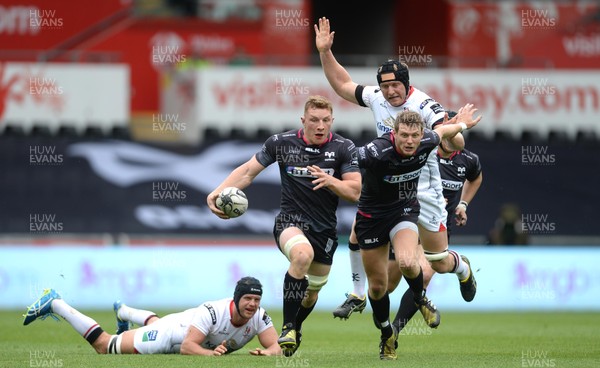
[388,111,483,332]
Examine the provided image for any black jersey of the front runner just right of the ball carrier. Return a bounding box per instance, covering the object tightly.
[358,129,440,217]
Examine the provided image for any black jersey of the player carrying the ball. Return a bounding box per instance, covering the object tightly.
[255,129,359,232]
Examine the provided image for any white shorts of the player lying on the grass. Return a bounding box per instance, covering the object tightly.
[133,312,189,354]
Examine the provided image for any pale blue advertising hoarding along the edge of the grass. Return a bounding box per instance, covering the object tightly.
[0,243,600,313]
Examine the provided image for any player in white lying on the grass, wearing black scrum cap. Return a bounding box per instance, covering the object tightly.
[23,277,281,356]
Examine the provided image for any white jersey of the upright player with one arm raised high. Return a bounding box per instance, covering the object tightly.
[357,86,445,202]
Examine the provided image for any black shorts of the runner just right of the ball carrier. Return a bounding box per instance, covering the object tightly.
[354,207,419,250]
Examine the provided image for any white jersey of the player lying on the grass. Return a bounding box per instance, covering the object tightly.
[191,298,273,353]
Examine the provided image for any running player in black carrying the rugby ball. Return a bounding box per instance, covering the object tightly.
[207,96,361,356]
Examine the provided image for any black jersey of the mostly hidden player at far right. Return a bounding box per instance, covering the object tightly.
[437,149,481,227]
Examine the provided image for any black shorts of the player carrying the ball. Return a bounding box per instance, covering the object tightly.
[273,213,338,266]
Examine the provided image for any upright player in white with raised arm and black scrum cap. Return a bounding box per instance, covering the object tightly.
[314,18,477,318]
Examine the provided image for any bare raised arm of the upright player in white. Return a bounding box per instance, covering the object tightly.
[315,17,358,105]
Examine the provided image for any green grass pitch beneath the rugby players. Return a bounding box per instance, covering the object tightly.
[0,310,600,368]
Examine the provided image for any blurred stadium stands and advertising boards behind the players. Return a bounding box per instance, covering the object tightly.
[0,0,600,311]
